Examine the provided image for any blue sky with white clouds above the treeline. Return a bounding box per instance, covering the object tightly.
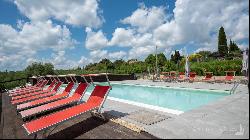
[0,0,249,71]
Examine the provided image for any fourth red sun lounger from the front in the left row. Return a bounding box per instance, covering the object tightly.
[11,82,62,105]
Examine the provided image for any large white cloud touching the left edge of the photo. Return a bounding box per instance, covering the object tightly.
[0,20,77,70]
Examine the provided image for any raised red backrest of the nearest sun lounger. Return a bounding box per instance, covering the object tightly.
[87,85,111,104]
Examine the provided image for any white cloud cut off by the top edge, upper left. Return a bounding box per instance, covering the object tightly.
[14,0,104,28]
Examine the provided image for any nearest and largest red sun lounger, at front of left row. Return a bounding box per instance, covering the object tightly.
[23,85,111,138]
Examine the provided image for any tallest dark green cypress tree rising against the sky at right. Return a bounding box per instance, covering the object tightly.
[218,27,228,57]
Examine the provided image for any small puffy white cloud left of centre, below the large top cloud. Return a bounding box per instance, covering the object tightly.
[85,27,108,50]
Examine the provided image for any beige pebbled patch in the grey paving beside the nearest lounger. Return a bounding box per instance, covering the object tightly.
[127,110,171,125]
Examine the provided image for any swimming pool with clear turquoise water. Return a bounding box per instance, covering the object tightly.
[62,84,229,114]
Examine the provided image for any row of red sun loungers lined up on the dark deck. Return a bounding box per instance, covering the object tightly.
[8,75,111,136]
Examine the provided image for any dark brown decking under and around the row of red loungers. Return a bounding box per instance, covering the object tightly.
[0,93,156,139]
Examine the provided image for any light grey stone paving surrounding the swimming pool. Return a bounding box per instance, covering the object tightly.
[101,80,249,138]
